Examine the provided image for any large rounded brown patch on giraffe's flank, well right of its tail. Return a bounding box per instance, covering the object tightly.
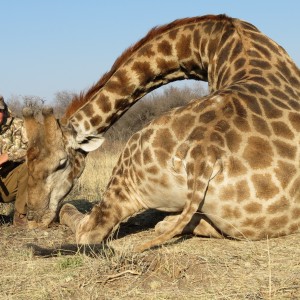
[243,137,273,169]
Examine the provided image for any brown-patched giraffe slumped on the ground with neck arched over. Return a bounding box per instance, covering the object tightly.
[25,15,300,251]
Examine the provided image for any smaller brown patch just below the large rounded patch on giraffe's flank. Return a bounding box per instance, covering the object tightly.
[251,174,279,200]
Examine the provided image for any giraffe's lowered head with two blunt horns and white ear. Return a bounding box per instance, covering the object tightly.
[23,108,104,227]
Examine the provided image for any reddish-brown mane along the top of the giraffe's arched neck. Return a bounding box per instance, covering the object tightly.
[63,14,231,120]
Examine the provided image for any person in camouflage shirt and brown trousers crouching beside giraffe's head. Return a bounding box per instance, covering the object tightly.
[0,95,28,227]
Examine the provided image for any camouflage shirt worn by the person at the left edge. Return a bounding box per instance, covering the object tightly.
[0,117,28,162]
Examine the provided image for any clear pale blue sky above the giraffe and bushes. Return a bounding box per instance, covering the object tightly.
[0,0,300,103]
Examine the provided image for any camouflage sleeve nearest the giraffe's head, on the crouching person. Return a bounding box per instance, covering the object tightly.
[7,119,28,161]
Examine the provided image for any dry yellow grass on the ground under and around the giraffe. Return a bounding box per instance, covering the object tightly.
[0,141,300,300]
